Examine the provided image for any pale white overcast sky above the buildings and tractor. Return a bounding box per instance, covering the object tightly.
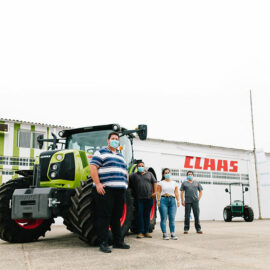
[0,0,270,152]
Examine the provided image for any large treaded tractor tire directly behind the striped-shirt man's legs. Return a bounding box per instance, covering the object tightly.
[65,179,134,245]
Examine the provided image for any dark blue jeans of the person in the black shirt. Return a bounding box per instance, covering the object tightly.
[138,198,153,234]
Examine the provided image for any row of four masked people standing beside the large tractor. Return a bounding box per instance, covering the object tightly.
[90,132,202,253]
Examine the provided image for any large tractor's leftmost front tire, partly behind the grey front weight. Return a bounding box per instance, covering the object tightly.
[0,177,54,243]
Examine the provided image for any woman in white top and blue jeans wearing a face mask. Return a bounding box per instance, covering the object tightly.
[157,168,180,240]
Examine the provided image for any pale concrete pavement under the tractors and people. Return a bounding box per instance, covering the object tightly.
[0,220,270,270]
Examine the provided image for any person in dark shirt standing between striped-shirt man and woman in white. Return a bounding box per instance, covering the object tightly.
[129,161,157,238]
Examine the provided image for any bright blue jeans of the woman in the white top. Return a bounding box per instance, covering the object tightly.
[159,197,177,233]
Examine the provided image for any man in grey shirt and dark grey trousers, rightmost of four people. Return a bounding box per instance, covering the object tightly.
[180,171,203,234]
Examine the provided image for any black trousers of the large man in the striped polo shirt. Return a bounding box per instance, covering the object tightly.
[93,187,126,244]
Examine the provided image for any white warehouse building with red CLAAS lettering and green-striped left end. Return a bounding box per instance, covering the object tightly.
[0,118,270,220]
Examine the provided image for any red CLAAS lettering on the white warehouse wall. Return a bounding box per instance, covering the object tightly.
[184,156,238,172]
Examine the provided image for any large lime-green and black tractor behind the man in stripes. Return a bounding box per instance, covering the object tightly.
[0,124,156,245]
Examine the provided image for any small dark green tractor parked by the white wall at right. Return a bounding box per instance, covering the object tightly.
[223,184,254,222]
